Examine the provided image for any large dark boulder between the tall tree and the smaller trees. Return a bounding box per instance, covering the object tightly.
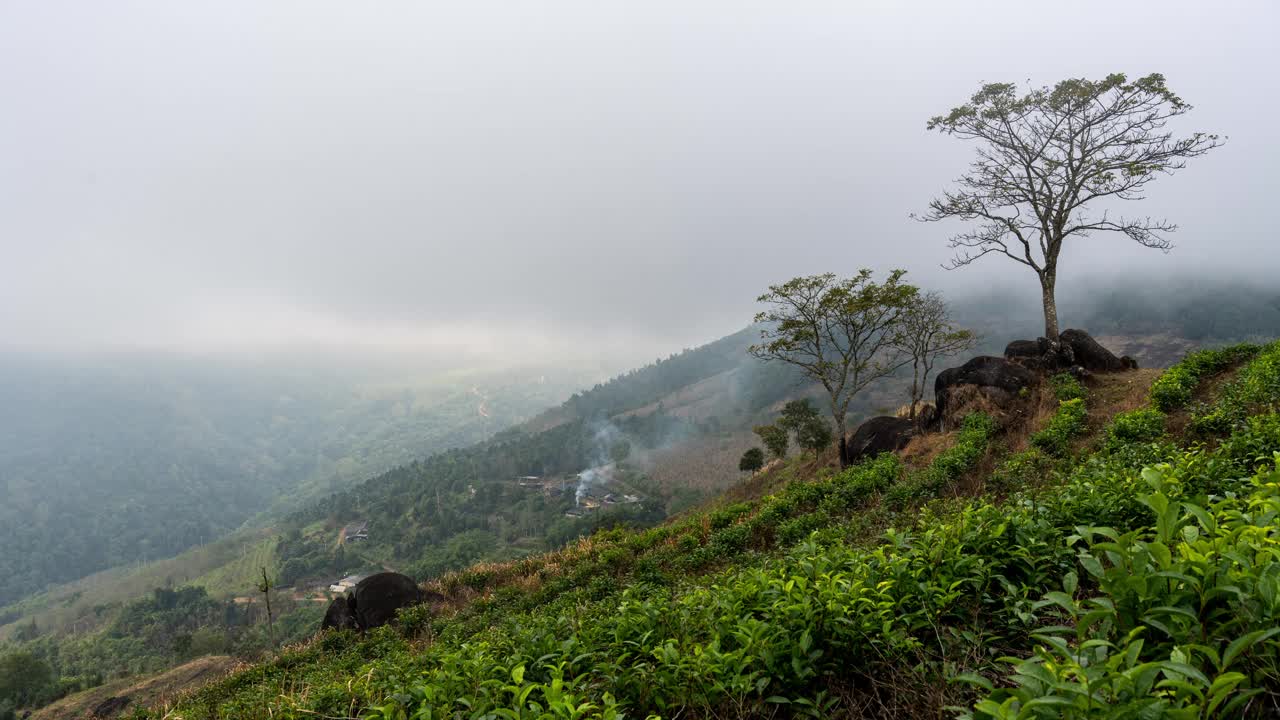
[933,355,1036,428]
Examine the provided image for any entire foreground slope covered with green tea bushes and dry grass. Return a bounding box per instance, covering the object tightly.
[122,343,1280,719]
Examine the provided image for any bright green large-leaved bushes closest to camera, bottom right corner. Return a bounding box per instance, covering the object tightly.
[966,454,1280,719]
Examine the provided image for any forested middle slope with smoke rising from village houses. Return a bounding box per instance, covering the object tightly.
[279,325,804,584]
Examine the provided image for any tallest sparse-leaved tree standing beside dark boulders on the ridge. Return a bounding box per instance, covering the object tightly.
[920,73,1222,342]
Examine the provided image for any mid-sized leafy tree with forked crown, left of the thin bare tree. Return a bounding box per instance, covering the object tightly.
[749,269,919,466]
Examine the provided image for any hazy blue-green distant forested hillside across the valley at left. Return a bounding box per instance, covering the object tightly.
[0,357,581,607]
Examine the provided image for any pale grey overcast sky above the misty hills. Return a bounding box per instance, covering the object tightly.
[0,0,1280,357]
